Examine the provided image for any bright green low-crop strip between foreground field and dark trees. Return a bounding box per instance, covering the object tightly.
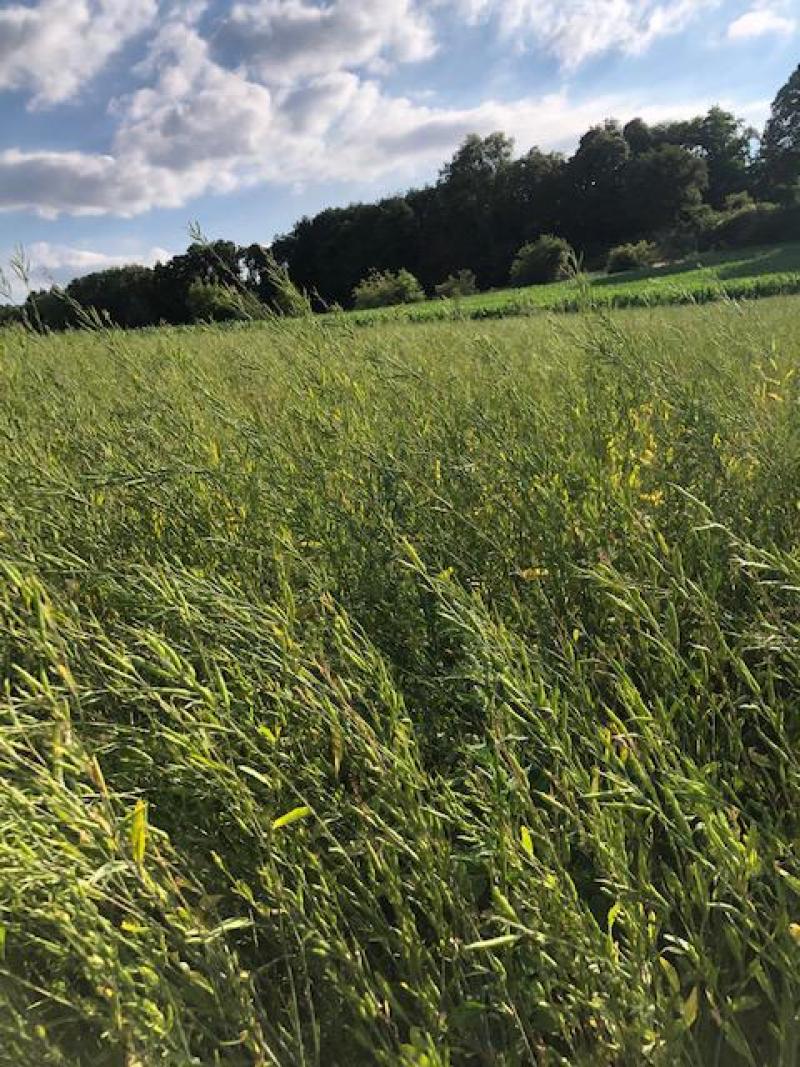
[349,243,800,324]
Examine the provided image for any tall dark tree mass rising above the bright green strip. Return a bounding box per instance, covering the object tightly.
[272,71,800,307]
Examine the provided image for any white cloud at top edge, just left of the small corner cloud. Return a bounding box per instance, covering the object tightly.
[452,0,720,69]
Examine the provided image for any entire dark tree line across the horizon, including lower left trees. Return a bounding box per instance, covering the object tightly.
[6,66,800,328]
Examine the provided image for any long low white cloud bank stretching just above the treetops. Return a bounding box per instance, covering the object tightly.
[0,82,768,216]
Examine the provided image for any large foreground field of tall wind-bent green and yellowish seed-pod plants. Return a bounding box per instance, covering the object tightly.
[0,298,800,1067]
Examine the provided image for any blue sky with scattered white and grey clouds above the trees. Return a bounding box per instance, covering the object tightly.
[0,0,800,292]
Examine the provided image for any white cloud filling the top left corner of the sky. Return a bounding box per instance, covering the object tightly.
[0,0,158,107]
